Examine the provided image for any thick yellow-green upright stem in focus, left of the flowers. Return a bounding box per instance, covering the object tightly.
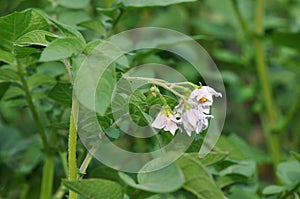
[68,97,79,199]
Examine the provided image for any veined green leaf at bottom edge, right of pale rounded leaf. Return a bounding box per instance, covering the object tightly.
[177,154,225,199]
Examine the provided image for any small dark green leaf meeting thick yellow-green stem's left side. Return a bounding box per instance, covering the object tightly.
[48,83,72,106]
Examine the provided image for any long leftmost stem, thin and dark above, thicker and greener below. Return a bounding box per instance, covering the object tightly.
[16,65,54,199]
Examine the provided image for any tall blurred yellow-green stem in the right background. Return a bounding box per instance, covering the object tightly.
[254,0,281,168]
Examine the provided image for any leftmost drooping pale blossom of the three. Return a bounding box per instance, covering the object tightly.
[151,111,181,135]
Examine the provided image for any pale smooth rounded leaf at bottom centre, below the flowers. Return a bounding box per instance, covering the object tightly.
[119,164,184,193]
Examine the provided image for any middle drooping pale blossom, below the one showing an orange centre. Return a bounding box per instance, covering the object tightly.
[182,108,213,136]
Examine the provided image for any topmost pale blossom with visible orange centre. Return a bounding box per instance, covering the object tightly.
[188,86,222,113]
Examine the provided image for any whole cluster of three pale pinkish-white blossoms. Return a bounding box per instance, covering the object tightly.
[152,86,222,136]
